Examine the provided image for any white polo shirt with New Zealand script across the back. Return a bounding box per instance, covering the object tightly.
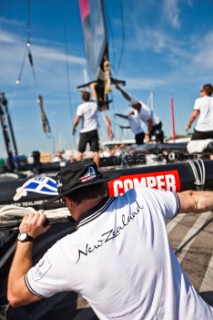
[25,187,213,320]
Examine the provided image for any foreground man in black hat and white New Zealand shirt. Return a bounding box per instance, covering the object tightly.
[8,161,213,320]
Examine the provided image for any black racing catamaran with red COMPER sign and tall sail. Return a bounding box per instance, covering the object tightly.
[0,0,213,320]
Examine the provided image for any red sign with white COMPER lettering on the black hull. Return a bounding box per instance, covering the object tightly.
[108,170,180,197]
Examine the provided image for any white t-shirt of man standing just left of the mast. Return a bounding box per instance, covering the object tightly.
[76,101,98,132]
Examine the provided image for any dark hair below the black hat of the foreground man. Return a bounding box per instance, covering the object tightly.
[67,182,107,204]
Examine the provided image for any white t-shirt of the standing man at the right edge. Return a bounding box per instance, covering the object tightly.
[194,96,213,131]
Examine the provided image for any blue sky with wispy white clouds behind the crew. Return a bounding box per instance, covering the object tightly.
[0,0,213,157]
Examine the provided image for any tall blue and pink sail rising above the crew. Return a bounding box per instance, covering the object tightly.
[79,0,107,81]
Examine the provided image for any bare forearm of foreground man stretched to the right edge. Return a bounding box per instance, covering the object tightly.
[177,190,213,213]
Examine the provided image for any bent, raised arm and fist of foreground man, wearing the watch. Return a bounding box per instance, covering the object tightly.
[7,213,50,307]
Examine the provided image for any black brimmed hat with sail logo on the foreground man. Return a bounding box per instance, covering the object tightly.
[46,159,121,204]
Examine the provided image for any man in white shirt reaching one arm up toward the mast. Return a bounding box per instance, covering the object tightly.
[116,85,164,143]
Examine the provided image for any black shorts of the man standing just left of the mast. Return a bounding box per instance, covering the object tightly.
[78,130,99,152]
